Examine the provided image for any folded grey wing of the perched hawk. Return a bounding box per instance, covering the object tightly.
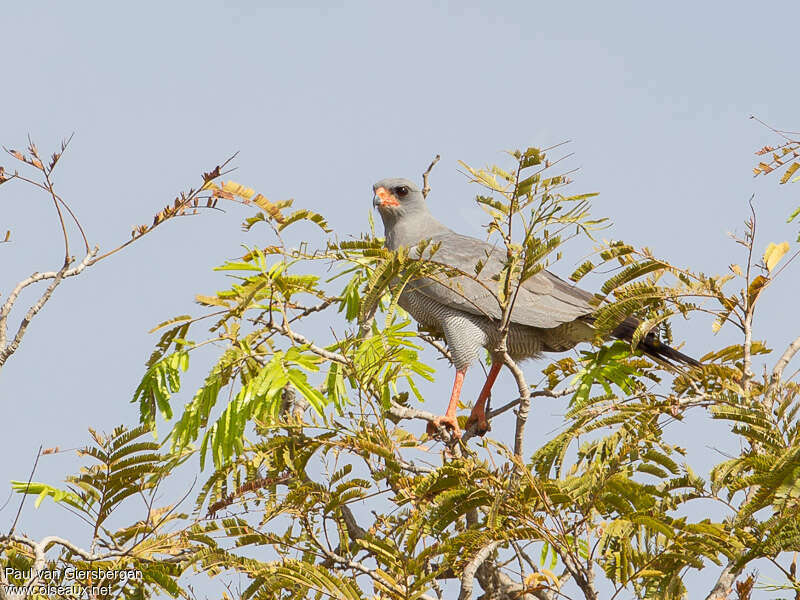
[407,232,594,329]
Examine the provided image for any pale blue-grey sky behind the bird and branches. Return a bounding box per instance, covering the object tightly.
[0,2,800,596]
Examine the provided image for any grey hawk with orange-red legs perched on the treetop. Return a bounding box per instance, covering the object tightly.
[373,179,699,436]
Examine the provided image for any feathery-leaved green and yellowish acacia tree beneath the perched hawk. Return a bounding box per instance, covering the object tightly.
[5,137,800,600]
